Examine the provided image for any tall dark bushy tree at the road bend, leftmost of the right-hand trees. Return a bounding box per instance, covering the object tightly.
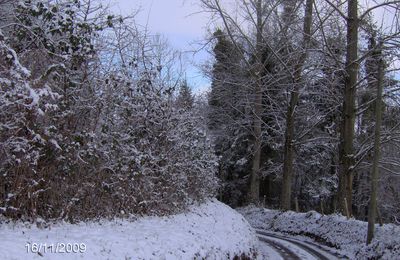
[208,30,251,206]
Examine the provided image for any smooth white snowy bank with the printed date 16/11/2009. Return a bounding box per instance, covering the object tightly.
[0,200,258,259]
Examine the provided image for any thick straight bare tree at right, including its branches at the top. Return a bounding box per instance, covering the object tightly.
[325,0,399,216]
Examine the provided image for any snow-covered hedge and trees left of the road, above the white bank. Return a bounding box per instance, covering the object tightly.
[0,0,217,222]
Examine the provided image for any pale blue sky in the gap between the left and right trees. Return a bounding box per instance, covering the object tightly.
[108,0,210,92]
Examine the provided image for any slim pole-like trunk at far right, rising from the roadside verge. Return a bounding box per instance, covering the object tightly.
[367,43,383,245]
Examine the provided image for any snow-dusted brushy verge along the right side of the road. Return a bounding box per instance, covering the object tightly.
[238,207,400,259]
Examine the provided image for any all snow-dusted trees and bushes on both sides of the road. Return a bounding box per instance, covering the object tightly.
[0,0,400,246]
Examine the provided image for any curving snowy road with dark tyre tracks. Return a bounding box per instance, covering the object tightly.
[256,229,341,260]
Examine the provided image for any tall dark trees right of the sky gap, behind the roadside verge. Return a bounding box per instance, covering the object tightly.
[202,0,400,231]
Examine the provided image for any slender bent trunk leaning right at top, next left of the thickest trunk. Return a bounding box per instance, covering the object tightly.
[281,0,314,210]
